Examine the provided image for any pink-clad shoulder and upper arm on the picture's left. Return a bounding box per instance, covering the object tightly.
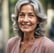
[6,36,20,53]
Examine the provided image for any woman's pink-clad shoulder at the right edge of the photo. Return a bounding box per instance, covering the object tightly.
[43,37,54,53]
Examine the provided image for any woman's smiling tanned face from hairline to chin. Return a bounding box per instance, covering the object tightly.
[18,4,38,32]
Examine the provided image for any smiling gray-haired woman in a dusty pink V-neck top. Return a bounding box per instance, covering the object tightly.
[6,0,54,53]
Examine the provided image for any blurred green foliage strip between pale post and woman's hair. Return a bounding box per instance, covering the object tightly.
[9,0,18,37]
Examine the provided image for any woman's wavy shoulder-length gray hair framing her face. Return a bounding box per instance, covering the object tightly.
[13,0,46,37]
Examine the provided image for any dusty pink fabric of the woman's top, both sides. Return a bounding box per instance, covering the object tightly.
[6,36,54,53]
